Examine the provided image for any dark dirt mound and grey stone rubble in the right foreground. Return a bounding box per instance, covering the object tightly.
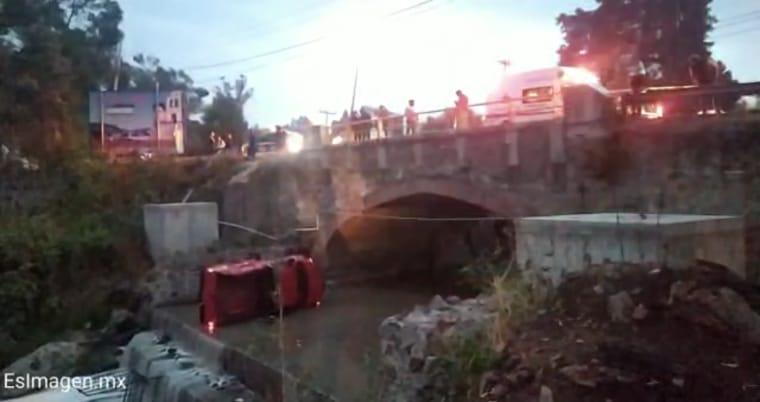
[381,264,760,402]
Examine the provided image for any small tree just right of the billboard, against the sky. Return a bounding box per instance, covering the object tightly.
[203,75,253,144]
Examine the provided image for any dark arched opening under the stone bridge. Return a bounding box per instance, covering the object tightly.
[326,192,514,296]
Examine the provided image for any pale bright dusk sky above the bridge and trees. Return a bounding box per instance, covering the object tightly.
[120,0,760,127]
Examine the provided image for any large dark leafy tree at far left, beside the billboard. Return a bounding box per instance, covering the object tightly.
[0,0,123,154]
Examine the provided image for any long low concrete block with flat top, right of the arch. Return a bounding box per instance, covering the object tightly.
[515,213,746,285]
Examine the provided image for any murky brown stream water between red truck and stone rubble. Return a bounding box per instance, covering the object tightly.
[211,287,432,401]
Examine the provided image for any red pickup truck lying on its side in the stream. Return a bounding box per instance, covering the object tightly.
[200,256,324,331]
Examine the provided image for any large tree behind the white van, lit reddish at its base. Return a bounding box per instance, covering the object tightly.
[557,0,716,88]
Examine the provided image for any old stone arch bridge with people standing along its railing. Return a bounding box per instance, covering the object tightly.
[222,120,756,276]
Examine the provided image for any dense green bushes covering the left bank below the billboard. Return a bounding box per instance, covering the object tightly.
[0,153,240,367]
